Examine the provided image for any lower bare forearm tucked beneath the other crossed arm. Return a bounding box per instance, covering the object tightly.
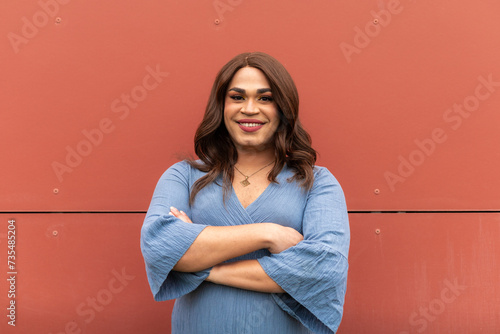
[207,260,285,293]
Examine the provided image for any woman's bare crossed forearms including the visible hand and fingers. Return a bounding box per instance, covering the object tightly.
[170,207,303,293]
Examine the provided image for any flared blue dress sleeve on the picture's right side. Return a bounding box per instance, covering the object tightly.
[259,168,350,334]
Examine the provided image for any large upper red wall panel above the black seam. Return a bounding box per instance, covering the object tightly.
[0,0,500,211]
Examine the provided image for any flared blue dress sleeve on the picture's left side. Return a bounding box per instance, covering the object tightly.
[141,162,210,301]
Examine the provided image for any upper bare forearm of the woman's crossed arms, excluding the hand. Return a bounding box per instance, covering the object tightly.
[173,223,272,272]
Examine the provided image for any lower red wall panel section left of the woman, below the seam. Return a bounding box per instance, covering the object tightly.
[0,214,173,334]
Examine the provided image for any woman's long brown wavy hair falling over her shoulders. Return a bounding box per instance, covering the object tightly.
[188,52,316,204]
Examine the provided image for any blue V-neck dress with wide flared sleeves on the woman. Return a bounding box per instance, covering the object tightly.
[141,162,350,334]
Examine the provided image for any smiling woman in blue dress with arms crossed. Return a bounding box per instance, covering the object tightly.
[141,52,349,334]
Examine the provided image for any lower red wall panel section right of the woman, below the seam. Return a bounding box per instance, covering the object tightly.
[339,213,500,334]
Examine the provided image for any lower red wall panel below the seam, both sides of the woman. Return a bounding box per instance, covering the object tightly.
[0,213,500,334]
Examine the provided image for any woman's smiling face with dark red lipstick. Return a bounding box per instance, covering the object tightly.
[224,67,280,151]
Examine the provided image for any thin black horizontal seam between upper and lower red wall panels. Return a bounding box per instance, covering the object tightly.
[0,210,500,215]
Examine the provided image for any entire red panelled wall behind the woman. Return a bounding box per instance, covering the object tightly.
[0,0,500,334]
